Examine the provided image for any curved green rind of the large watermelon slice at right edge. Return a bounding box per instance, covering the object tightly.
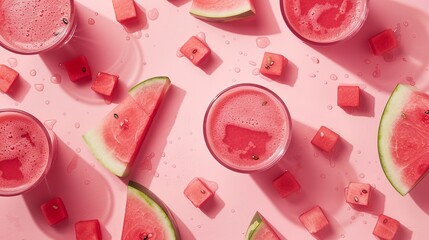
[378,84,416,196]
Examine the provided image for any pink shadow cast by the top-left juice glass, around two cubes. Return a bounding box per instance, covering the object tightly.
[40,3,144,104]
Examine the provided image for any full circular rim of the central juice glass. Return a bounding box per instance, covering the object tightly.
[203,83,292,173]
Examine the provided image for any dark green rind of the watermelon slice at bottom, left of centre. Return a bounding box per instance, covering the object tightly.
[128,181,180,240]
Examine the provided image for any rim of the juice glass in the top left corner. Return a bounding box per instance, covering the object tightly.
[0,0,77,55]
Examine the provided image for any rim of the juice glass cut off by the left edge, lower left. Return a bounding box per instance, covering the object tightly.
[0,108,54,197]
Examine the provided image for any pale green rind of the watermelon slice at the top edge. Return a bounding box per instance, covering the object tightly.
[189,3,256,22]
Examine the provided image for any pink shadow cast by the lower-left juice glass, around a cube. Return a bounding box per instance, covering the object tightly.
[23,139,114,239]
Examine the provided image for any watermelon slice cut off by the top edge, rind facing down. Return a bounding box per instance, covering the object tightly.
[189,0,256,22]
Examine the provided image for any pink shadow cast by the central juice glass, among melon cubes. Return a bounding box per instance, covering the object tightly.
[251,121,357,231]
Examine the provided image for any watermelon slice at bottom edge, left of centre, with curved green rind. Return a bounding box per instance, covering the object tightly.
[121,181,180,240]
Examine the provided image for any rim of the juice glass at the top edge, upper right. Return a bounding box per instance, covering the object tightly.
[280,0,369,46]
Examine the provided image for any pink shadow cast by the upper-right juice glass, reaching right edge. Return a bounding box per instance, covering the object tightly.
[313,1,429,92]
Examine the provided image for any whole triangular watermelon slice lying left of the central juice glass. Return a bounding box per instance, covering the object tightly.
[83,77,171,177]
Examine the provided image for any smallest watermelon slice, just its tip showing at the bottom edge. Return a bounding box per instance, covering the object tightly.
[245,212,280,240]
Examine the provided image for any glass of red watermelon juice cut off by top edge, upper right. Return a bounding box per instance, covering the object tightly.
[280,0,368,45]
